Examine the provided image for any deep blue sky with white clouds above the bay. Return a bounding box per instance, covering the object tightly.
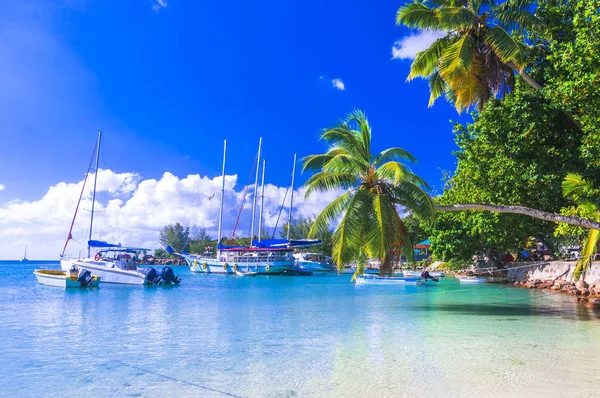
[0,0,468,259]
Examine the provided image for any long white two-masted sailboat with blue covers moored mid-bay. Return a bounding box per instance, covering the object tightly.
[165,138,321,275]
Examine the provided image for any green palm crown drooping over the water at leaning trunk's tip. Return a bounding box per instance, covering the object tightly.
[303,111,435,276]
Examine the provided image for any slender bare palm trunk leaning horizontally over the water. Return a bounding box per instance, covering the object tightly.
[435,203,600,230]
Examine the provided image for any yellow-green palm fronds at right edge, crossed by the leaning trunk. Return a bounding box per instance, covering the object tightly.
[562,173,600,279]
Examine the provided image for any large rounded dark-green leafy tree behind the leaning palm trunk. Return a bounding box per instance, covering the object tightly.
[429,83,588,261]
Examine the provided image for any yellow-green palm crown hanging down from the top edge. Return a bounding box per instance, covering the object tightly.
[396,0,542,112]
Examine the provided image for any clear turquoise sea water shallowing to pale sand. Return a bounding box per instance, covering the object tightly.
[0,262,600,397]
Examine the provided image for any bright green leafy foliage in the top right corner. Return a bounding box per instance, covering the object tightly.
[537,0,600,168]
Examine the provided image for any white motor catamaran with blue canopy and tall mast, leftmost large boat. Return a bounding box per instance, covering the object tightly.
[60,131,181,285]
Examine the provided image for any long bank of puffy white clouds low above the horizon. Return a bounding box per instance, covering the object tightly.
[0,169,341,259]
